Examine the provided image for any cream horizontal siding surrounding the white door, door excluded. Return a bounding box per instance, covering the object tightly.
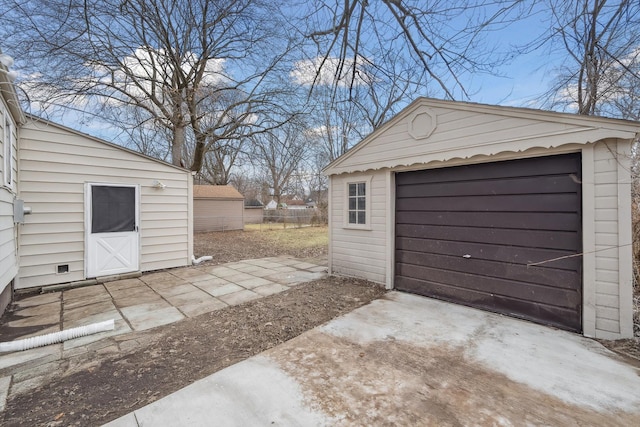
[16,120,192,289]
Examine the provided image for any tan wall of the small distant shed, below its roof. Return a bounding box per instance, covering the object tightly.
[193,199,244,233]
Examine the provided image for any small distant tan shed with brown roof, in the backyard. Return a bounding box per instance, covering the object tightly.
[193,185,244,232]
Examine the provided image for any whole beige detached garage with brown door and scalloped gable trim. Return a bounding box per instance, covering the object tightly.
[325,98,640,339]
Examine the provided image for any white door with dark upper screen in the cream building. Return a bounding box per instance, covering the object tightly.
[85,184,140,277]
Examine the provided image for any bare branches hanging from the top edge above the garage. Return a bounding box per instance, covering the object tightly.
[303,0,533,99]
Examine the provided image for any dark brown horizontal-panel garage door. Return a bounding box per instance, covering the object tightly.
[395,154,582,332]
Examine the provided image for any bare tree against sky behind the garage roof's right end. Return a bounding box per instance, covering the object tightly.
[537,0,640,118]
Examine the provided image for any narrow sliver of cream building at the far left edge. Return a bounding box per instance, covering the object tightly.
[0,55,25,314]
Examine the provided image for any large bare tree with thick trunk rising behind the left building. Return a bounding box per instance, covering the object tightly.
[0,0,298,171]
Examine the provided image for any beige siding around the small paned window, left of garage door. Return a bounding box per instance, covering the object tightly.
[330,172,389,284]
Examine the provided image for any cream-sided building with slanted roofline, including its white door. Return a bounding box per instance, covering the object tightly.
[16,117,193,289]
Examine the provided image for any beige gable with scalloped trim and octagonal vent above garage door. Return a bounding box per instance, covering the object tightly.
[323,98,640,175]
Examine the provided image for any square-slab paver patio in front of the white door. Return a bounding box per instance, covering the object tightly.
[0,257,326,410]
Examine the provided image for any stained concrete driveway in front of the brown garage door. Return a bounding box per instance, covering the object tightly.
[109,292,640,426]
